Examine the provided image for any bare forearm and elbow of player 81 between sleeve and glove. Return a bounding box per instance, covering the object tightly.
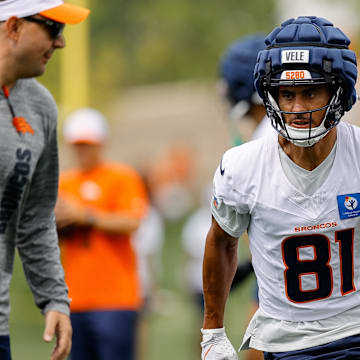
[203,218,238,329]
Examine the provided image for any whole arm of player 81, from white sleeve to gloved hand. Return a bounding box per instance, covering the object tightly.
[201,150,250,360]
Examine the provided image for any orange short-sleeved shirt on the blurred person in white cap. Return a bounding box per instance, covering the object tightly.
[59,163,147,311]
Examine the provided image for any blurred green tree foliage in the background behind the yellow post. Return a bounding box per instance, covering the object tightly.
[43,0,276,105]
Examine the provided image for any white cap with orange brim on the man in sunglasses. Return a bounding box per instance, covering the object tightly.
[0,0,90,24]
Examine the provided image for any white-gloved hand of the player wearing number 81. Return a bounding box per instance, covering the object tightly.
[201,328,238,360]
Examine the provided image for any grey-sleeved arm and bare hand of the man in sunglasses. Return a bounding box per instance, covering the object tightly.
[16,108,71,360]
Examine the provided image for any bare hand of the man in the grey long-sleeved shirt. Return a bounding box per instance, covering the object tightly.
[43,311,72,360]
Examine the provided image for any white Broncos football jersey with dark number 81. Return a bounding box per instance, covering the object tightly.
[212,123,360,321]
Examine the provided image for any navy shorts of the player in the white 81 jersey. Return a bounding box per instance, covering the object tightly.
[264,335,360,360]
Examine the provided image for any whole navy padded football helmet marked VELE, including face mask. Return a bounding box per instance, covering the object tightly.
[254,16,357,147]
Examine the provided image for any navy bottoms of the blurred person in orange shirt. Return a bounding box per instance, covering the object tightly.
[70,311,138,360]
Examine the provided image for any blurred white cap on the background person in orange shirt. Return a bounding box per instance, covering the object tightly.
[63,108,108,144]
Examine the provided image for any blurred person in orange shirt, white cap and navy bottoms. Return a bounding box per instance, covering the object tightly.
[55,108,147,360]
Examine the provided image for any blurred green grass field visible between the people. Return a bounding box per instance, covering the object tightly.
[10,217,253,360]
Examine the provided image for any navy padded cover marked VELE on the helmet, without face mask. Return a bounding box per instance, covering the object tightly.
[254,16,357,111]
